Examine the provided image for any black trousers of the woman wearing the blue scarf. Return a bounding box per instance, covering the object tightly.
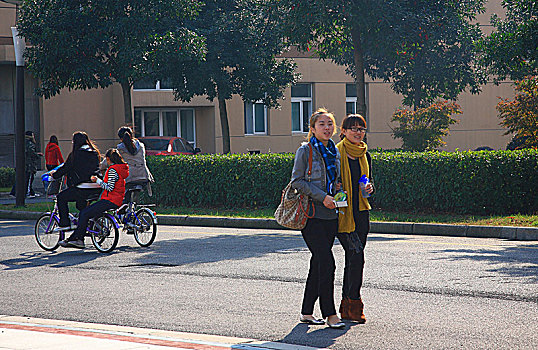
[301,219,338,318]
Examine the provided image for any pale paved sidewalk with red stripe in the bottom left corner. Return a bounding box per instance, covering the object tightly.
[0,315,317,350]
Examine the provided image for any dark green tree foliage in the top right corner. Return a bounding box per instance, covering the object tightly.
[480,0,538,82]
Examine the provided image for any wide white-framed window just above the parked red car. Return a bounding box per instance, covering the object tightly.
[135,108,196,147]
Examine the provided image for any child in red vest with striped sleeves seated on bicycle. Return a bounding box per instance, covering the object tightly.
[60,148,129,249]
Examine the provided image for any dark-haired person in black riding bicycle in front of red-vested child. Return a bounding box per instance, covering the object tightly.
[50,131,101,230]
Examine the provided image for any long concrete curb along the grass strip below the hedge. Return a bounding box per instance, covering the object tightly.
[0,210,538,241]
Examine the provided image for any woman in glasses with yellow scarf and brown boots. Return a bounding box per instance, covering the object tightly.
[336,114,374,323]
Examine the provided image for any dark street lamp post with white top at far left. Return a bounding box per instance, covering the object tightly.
[11,27,27,206]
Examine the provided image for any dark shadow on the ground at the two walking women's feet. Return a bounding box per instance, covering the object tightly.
[278,322,358,348]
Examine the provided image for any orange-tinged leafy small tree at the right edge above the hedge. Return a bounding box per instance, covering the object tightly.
[497,76,538,148]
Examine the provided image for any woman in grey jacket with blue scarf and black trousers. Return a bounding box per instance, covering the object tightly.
[292,108,344,328]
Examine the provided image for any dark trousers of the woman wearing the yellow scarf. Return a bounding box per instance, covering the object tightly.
[336,210,370,300]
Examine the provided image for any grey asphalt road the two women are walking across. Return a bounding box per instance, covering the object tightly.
[0,220,538,349]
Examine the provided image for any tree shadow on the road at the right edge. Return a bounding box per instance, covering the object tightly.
[436,244,538,283]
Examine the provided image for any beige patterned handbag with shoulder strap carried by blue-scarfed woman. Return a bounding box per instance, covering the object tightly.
[275,143,315,230]
